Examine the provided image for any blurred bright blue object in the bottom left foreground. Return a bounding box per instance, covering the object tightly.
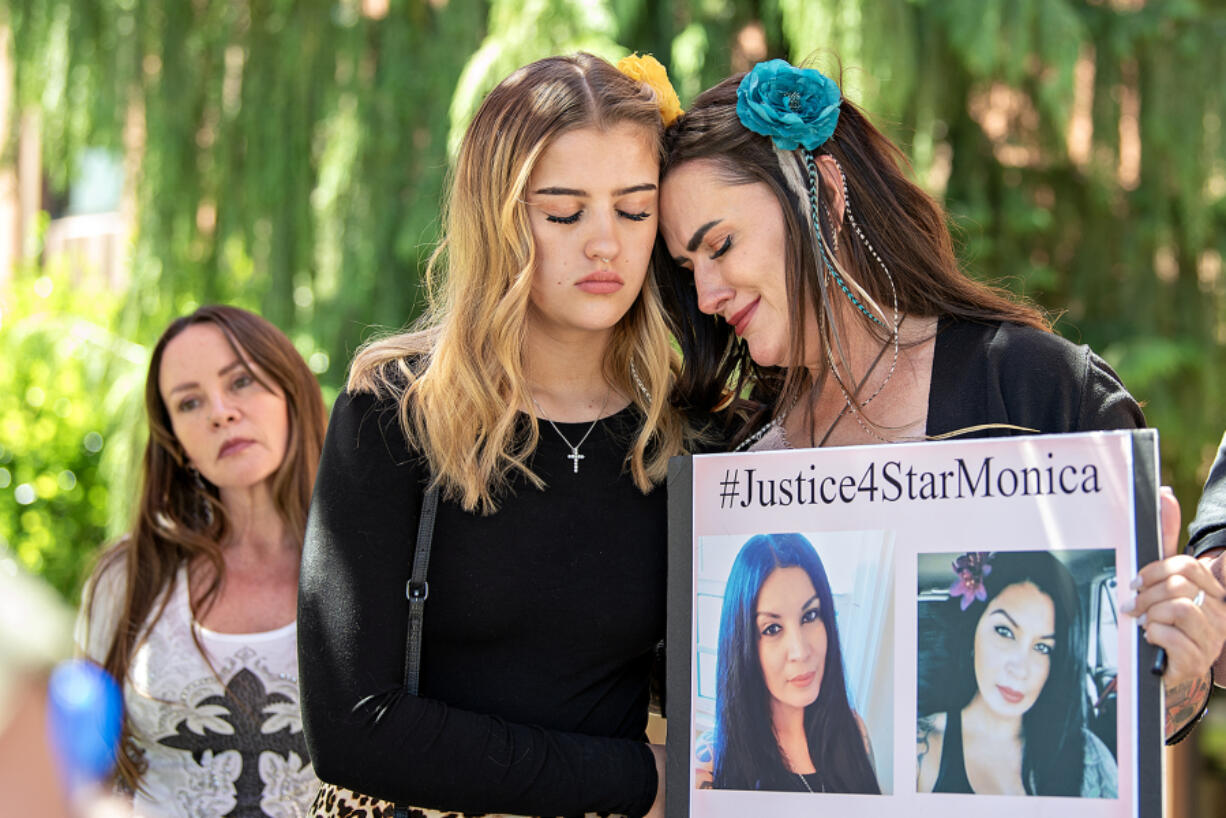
[47,660,123,792]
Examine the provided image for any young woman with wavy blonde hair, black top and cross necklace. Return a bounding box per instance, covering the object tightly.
[299,54,688,816]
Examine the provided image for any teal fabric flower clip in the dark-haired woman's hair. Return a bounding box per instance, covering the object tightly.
[737,60,842,151]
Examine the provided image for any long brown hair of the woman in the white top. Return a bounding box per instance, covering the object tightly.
[83,305,327,787]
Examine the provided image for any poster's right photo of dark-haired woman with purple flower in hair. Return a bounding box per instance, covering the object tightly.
[916,549,1118,798]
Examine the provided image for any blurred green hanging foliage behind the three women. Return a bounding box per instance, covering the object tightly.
[0,0,1226,608]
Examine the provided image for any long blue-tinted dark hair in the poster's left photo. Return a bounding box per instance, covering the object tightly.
[714,533,881,793]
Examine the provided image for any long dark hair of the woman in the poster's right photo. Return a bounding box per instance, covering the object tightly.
[918,551,1086,796]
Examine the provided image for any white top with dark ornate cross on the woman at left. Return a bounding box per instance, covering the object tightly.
[77,567,319,818]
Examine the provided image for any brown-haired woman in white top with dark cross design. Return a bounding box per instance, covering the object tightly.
[77,307,325,817]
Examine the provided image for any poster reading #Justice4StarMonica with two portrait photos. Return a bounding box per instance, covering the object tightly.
[667,429,1162,818]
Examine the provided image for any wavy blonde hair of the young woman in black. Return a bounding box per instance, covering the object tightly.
[348,54,689,514]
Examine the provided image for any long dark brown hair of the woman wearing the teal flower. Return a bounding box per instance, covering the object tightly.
[655,74,1049,441]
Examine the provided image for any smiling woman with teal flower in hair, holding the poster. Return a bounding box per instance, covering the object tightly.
[656,60,1226,736]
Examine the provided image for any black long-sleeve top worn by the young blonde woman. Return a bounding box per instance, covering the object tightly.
[298,394,667,816]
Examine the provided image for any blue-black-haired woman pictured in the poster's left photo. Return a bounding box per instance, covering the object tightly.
[695,533,881,793]
